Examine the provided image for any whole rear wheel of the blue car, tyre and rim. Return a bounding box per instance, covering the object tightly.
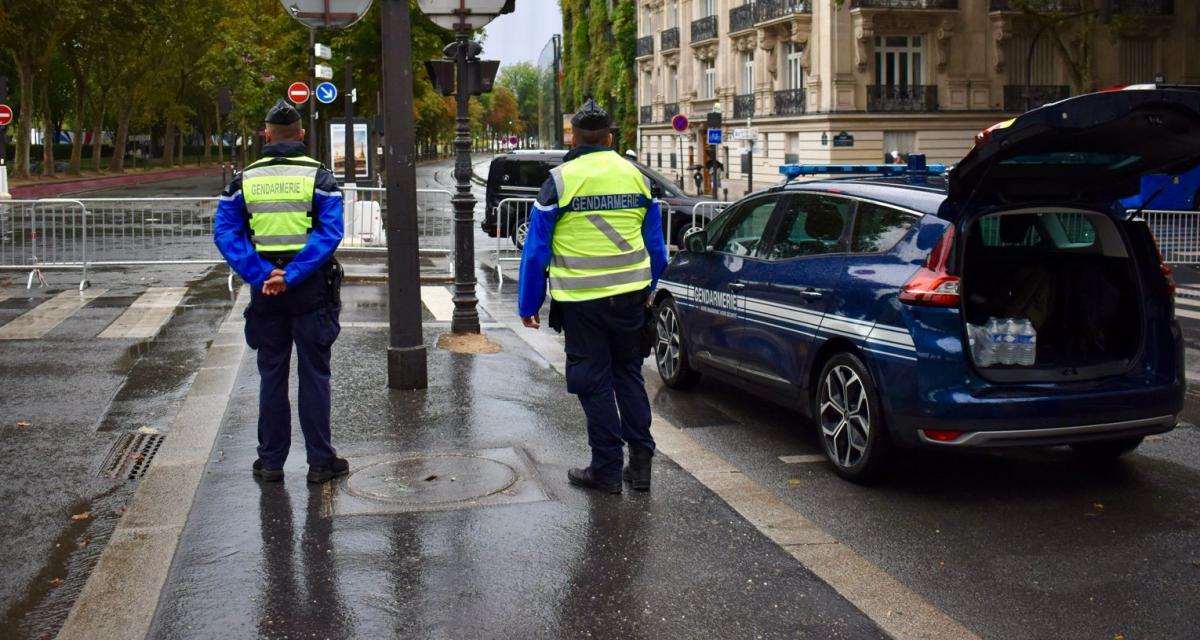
[812,353,890,484]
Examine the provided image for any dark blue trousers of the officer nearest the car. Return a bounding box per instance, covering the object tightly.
[559,292,654,480]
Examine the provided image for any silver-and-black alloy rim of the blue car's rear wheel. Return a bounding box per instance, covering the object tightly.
[818,365,871,468]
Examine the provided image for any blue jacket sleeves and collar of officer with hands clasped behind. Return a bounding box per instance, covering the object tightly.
[212,142,344,288]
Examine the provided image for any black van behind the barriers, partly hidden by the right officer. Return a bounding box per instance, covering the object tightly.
[480,149,716,249]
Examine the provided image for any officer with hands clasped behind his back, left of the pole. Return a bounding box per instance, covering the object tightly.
[214,100,349,483]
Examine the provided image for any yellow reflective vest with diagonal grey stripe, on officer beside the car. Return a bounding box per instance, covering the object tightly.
[550,151,652,303]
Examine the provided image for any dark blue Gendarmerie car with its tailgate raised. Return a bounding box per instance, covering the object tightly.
[654,90,1200,482]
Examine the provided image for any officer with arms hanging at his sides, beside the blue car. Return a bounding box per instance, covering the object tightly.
[517,100,667,494]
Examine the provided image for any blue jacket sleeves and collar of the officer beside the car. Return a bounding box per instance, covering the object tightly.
[517,146,667,318]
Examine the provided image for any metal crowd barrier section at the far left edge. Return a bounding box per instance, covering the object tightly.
[0,198,88,289]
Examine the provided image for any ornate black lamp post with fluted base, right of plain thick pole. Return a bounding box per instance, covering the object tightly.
[416,0,516,334]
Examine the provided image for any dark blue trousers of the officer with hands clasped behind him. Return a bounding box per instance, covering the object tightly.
[246,270,341,468]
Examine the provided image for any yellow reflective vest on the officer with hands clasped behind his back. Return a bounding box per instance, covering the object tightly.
[241,156,320,253]
